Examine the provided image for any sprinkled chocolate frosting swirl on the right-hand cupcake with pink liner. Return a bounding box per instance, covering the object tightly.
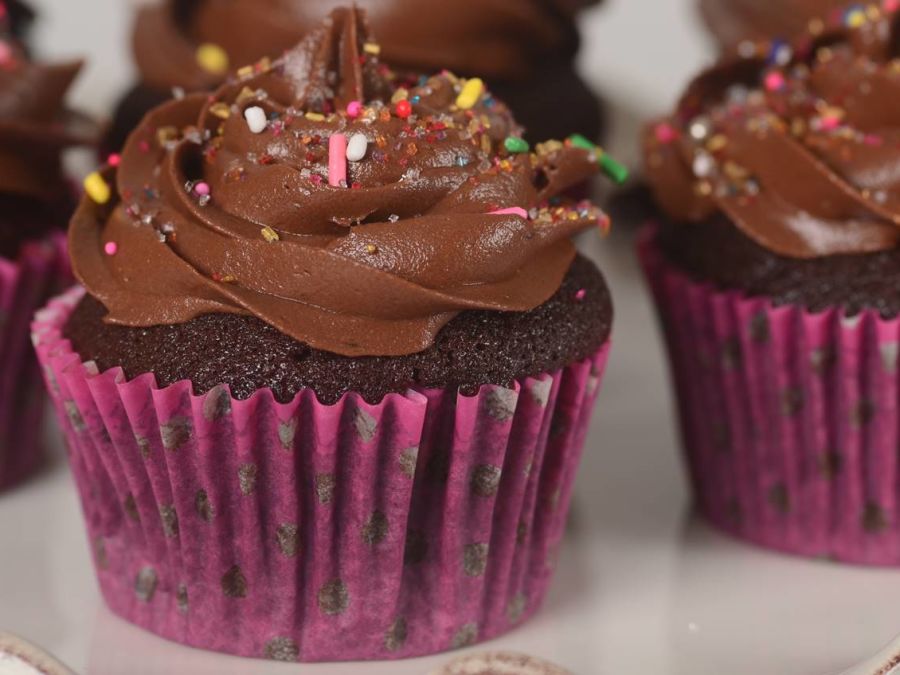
[645,5,900,258]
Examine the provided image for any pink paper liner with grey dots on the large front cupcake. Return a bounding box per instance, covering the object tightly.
[33,289,608,661]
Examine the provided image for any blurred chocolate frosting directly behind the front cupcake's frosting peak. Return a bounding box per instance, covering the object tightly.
[133,0,598,91]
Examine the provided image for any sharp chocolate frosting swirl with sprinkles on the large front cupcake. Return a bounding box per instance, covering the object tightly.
[70,9,607,356]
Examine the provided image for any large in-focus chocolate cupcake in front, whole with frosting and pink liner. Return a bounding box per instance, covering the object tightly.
[33,3,624,661]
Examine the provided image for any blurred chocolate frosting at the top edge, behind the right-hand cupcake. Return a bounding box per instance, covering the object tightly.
[700,0,852,49]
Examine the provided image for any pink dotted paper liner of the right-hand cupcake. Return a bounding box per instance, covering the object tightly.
[639,227,900,565]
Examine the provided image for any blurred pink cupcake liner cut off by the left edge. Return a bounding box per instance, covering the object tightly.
[0,235,71,489]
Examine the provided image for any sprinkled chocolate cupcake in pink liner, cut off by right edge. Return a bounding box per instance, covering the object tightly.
[641,5,900,565]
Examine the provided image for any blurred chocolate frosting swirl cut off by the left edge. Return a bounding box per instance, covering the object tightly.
[0,3,96,200]
